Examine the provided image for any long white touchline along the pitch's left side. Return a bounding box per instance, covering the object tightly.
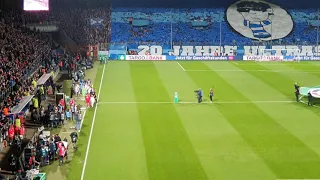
[81,64,106,180]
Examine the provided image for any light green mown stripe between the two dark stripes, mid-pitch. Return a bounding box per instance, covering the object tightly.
[154,62,276,180]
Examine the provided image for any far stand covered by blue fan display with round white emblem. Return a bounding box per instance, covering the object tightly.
[110,6,319,54]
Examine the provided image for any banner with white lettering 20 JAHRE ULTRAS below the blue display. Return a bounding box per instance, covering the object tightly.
[121,44,320,56]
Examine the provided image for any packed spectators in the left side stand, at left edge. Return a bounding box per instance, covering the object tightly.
[0,11,55,153]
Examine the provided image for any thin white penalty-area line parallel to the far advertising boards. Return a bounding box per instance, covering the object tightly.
[185,69,320,74]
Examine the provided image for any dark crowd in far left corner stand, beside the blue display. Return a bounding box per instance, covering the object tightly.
[24,7,111,45]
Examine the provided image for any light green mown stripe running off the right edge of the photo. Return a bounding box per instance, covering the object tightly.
[230,61,320,155]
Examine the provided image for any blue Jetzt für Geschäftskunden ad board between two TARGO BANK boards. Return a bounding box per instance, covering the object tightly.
[166,56,243,61]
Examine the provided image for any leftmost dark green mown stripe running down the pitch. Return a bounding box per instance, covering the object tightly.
[130,62,207,180]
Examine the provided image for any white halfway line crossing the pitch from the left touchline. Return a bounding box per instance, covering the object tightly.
[99,101,296,104]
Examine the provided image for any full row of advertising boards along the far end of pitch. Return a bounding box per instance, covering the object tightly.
[110,55,320,61]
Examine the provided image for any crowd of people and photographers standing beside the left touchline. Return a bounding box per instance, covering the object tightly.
[17,78,96,174]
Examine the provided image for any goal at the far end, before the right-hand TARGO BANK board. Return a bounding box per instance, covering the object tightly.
[255,49,301,62]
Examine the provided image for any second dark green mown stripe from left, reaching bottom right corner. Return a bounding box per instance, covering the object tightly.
[182,63,320,178]
